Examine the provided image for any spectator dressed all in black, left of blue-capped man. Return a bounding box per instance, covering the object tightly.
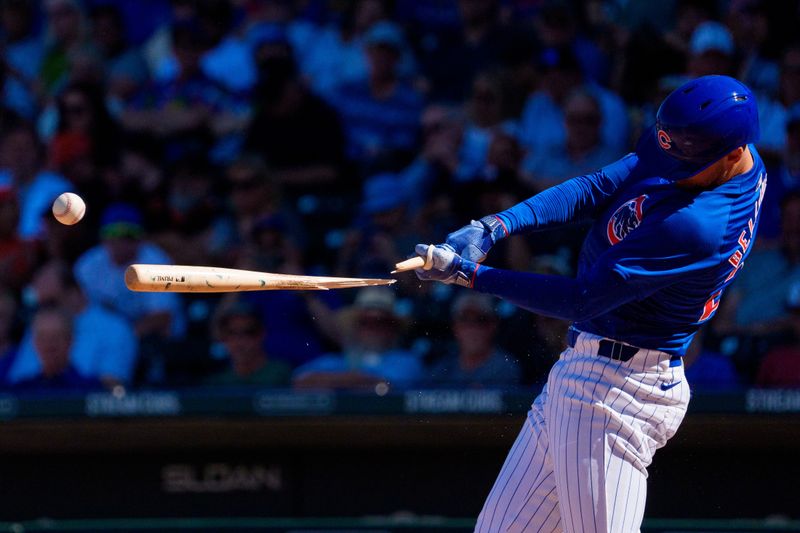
[244,29,352,198]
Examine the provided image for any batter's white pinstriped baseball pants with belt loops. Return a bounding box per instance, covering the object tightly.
[475,333,689,533]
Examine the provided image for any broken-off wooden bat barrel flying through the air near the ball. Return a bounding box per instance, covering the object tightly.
[125,265,397,292]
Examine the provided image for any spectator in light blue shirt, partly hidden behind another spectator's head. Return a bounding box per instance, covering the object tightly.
[520,48,629,158]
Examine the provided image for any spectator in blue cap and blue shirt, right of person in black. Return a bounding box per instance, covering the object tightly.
[330,22,423,168]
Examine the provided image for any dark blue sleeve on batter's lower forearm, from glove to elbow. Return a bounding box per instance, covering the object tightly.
[473,266,630,322]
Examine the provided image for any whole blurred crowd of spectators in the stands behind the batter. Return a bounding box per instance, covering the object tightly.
[0,0,800,391]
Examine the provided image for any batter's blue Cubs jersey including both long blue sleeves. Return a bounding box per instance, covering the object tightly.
[473,134,766,355]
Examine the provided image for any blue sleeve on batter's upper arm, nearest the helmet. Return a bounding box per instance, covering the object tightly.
[496,153,638,235]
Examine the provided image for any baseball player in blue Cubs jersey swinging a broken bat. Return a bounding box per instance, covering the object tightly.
[415,76,766,533]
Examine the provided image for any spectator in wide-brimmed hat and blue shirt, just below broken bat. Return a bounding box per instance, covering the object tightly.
[293,287,422,389]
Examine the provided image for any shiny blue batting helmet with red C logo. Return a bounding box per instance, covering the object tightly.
[655,76,759,167]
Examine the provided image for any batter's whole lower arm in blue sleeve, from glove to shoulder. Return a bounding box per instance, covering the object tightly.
[473,212,719,322]
